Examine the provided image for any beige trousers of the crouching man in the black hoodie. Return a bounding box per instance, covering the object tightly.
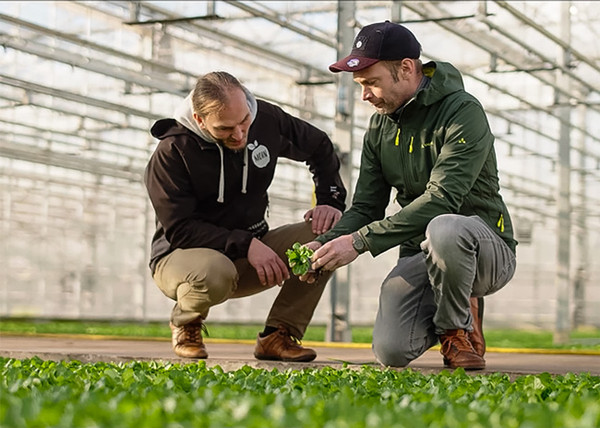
[149,222,331,338]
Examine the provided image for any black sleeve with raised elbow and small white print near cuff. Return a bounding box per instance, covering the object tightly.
[261,102,346,211]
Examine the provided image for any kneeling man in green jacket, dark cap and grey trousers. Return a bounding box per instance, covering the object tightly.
[301,21,517,370]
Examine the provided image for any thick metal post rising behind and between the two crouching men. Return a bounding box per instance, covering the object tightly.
[325,0,356,342]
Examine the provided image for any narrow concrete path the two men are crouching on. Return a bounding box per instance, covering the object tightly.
[0,333,600,375]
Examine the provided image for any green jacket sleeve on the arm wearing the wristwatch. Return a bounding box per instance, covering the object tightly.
[360,101,494,256]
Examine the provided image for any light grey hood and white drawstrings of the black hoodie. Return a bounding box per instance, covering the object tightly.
[166,86,258,203]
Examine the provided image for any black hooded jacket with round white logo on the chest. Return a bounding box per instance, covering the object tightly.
[144,100,346,273]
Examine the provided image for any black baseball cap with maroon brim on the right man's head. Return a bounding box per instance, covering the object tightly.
[329,21,421,73]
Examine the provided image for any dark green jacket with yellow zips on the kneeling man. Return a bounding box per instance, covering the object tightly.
[317,62,517,256]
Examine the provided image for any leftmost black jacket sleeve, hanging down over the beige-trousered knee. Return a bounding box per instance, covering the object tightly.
[144,142,253,260]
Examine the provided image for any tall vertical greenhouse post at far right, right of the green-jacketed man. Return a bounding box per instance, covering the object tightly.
[553,1,571,344]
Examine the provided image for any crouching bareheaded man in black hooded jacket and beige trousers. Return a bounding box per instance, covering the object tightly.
[145,72,346,361]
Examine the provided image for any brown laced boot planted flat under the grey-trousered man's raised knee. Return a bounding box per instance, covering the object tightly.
[440,329,485,370]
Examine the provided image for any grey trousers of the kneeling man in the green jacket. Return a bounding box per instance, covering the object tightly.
[373,214,516,367]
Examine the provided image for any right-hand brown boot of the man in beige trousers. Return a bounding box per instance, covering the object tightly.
[254,325,317,362]
